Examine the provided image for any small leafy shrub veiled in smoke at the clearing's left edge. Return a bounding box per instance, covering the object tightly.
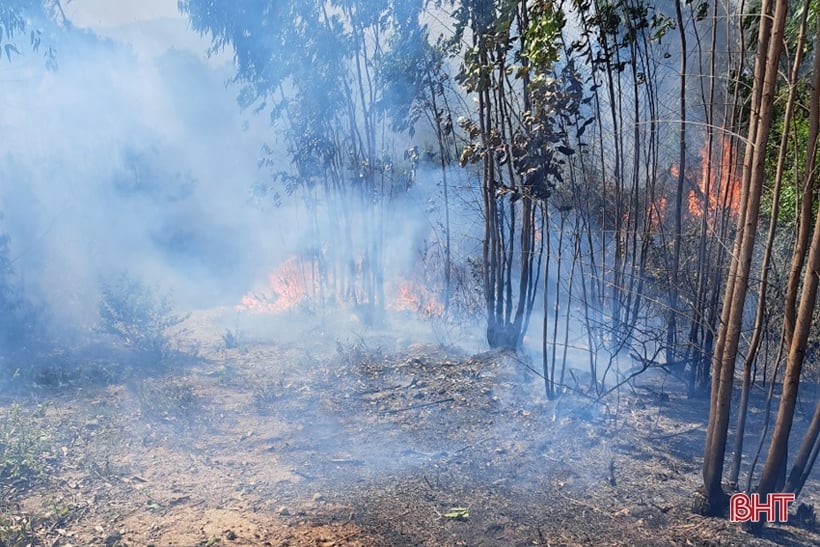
[100,274,188,362]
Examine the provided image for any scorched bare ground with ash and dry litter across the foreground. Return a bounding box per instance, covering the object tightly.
[0,310,820,547]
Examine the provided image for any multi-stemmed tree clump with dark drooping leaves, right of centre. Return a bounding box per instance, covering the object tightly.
[446,0,582,348]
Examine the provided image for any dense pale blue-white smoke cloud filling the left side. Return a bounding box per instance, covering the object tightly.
[0,24,284,342]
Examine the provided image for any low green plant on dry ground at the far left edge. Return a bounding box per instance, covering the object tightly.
[0,403,50,481]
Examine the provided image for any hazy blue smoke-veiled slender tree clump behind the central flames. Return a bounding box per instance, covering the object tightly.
[179,0,422,319]
